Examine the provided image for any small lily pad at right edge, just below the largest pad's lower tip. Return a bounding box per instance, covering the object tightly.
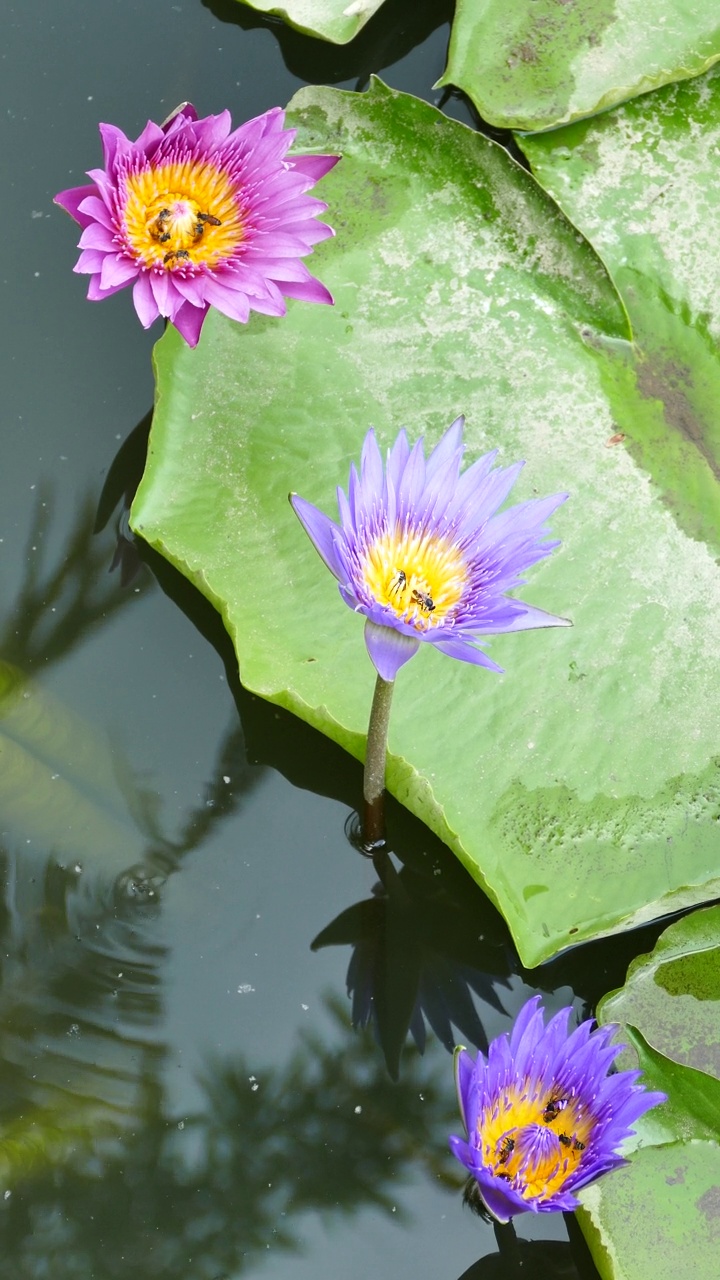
[598,906,720,1085]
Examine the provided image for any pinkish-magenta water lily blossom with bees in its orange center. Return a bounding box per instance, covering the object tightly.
[55,104,338,347]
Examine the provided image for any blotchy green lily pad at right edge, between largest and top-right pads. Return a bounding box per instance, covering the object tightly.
[519,70,720,550]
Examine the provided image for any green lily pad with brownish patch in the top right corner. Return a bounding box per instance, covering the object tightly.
[439,0,720,132]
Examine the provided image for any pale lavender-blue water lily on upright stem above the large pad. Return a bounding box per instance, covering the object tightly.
[291,417,570,681]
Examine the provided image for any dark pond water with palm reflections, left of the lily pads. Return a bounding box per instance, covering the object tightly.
[0,0,655,1280]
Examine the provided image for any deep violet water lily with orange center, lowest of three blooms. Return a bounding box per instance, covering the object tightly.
[450,996,666,1222]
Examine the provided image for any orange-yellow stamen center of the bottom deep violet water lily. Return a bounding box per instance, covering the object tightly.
[478,1084,594,1199]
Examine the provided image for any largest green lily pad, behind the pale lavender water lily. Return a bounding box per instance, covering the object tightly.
[132,82,720,965]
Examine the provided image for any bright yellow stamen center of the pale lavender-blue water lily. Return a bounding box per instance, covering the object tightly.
[363,527,468,631]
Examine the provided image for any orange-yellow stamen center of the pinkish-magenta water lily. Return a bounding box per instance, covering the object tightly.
[123,160,243,271]
